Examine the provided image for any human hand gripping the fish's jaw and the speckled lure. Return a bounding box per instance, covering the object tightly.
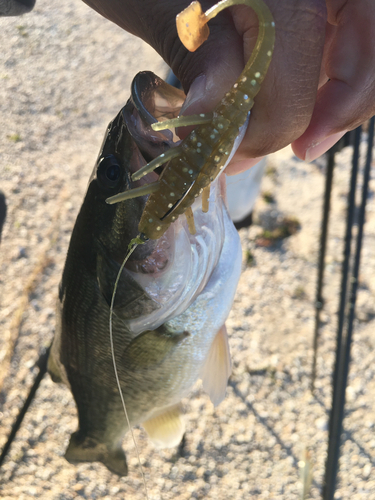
[84,0,375,174]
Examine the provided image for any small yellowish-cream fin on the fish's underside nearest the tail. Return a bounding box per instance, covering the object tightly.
[141,403,185,448]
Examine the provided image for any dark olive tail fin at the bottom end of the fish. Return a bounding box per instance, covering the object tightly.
[65,431,128,476]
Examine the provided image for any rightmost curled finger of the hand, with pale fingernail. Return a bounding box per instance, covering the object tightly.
[292,0,375,161]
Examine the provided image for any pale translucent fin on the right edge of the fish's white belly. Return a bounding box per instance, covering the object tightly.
[200,324,232,406]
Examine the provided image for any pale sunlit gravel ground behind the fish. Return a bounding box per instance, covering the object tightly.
[0,0,375,500]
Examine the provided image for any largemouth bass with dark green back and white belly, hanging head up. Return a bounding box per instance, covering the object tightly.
[48,72,241,475]
